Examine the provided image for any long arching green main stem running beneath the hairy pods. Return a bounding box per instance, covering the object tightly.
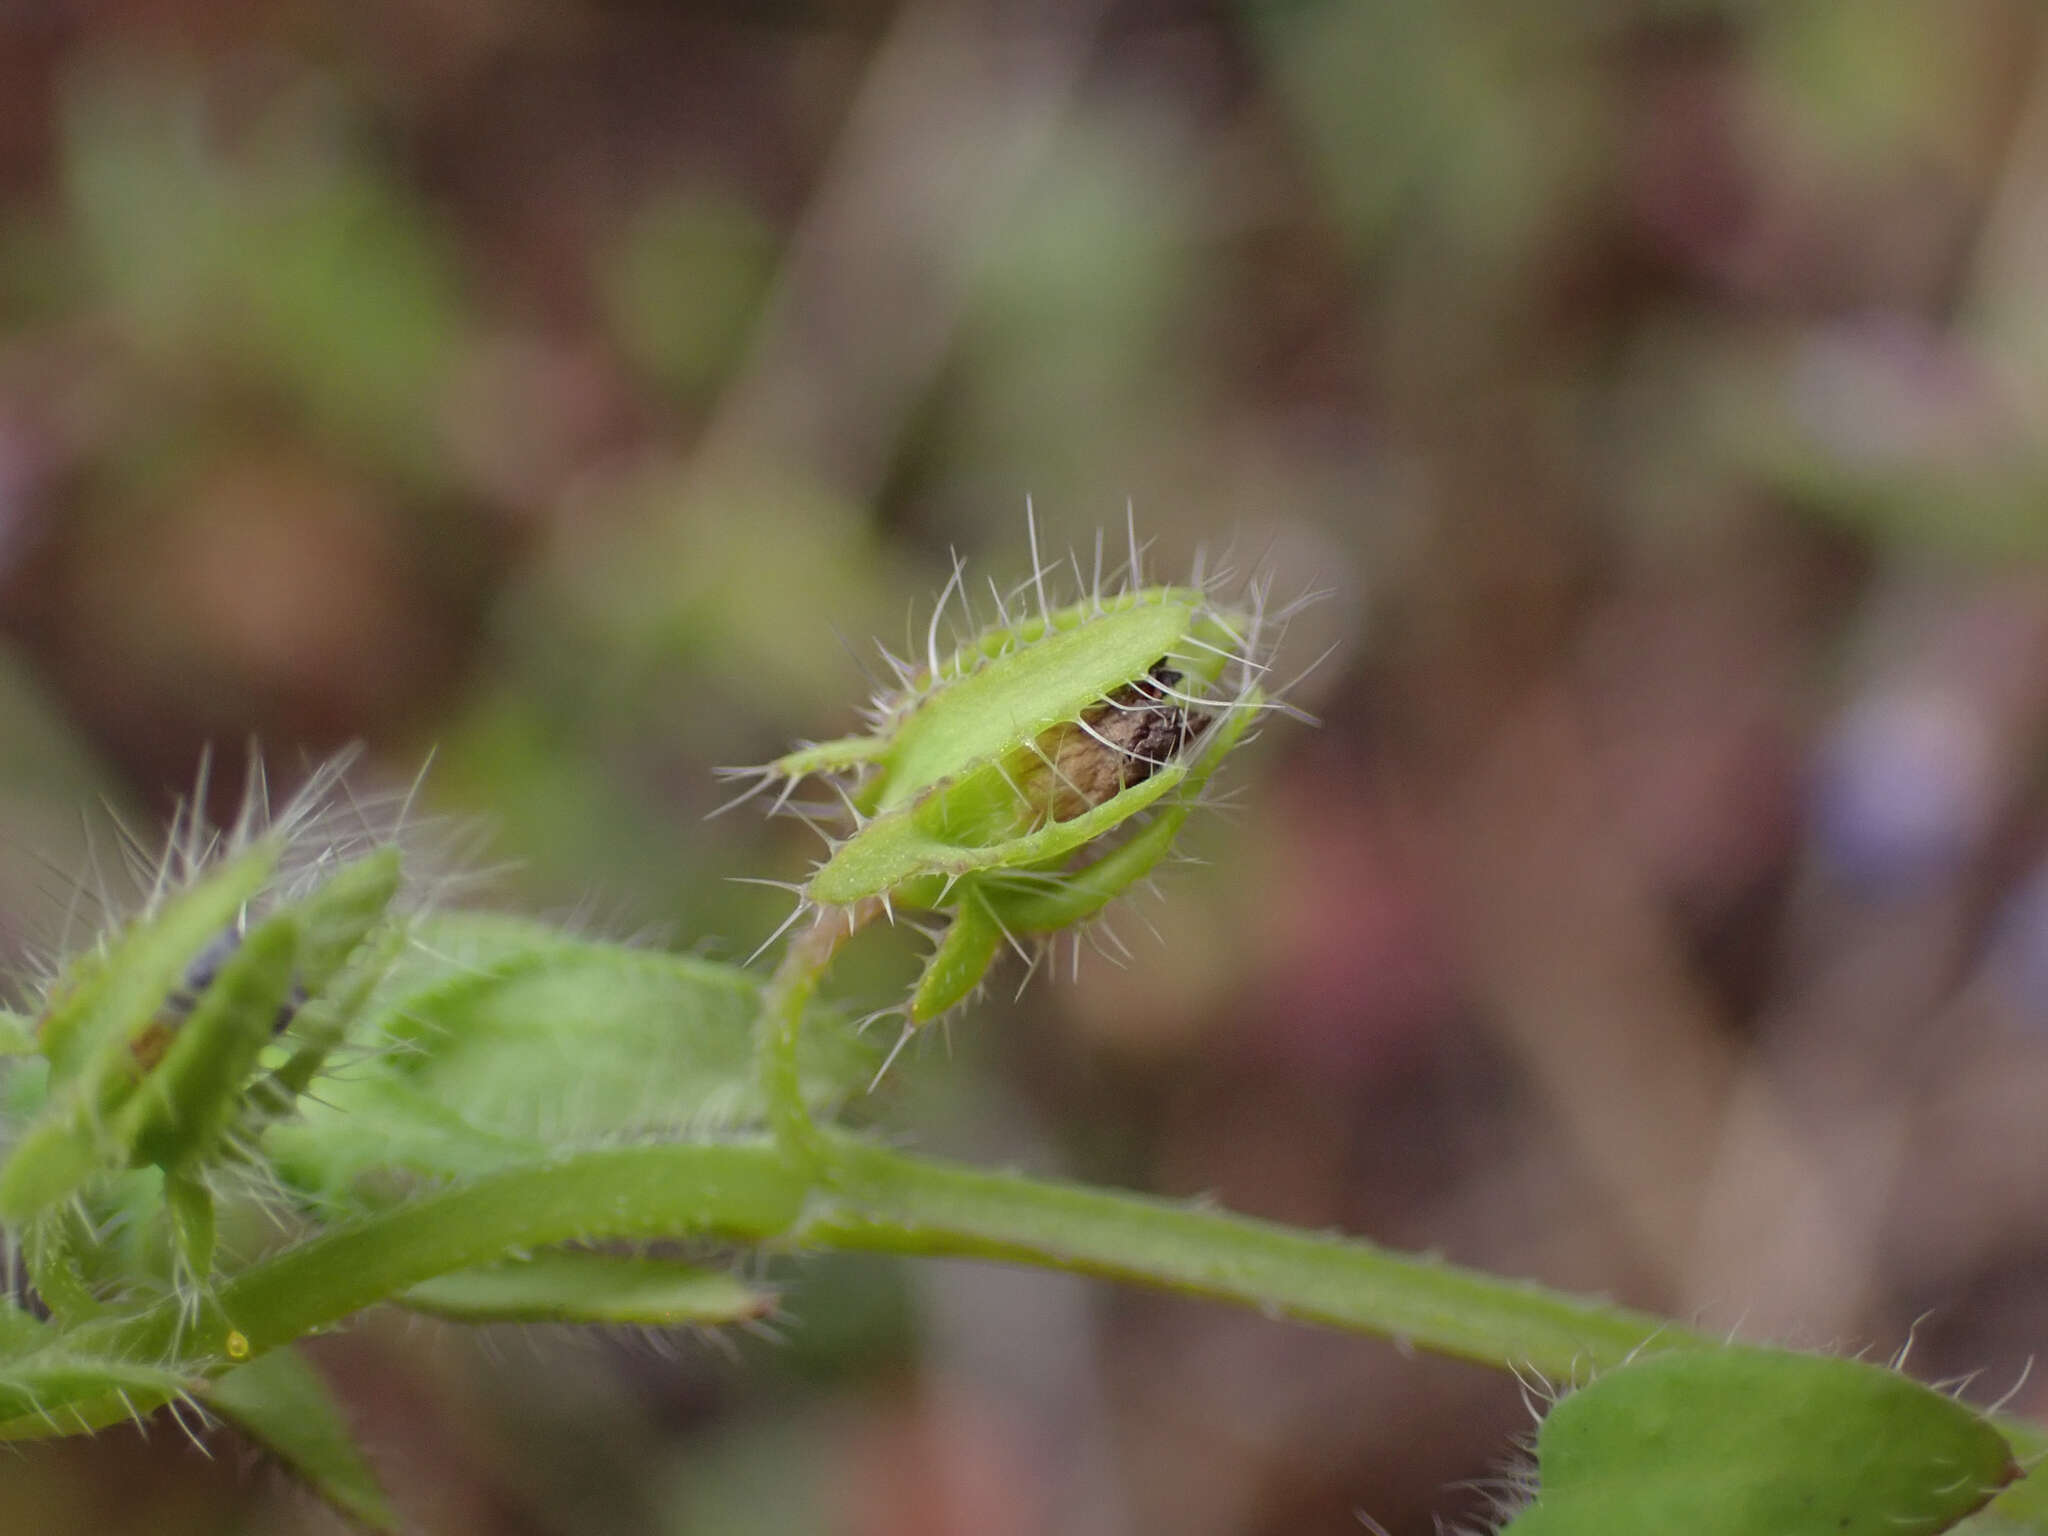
[0,1124,1708,1440]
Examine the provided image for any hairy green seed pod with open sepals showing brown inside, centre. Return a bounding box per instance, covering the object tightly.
[741,536,1270,1024]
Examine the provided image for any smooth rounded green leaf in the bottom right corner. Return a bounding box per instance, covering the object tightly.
[1503,1348,2017,1536]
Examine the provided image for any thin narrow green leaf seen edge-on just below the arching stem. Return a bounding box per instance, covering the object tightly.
[399,1249,774,1327]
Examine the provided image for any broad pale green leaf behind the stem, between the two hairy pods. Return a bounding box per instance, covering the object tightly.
[266,913,874,1204]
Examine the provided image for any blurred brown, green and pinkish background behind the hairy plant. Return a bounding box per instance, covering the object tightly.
[0,0,2048,1536]
